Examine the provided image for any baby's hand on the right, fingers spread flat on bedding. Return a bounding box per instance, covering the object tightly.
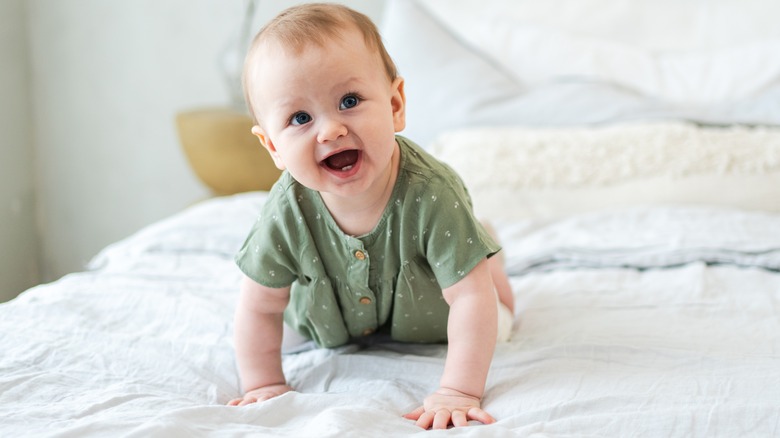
[404,388,496,429]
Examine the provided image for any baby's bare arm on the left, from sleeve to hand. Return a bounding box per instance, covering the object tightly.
[228,276,292,406]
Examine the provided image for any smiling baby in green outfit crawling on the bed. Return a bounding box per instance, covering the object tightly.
[228,4,513,429]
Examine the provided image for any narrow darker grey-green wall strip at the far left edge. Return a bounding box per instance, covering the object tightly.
[0,0,38,302]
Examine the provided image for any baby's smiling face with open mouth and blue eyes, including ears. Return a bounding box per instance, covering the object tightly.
[247,30,404,200]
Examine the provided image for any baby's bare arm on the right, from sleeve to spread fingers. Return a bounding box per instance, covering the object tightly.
[405,260,498,429]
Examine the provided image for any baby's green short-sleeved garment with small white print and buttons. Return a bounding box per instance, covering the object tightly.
[236,136,500,347]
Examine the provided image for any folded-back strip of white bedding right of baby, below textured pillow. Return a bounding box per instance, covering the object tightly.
[503,206,780,275]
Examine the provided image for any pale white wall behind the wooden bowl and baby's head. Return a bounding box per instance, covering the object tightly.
[25,0,383,280]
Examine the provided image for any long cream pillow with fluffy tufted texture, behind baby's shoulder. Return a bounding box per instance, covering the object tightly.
[430,122,780,219]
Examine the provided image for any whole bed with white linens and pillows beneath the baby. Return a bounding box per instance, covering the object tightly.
[0,0,780,437]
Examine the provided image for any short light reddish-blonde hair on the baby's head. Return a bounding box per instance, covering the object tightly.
[241,3,398,123]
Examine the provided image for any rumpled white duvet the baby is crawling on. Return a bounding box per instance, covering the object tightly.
[0,194,780,437]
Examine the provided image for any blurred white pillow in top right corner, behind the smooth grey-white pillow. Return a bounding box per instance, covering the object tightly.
[421,0,780,103]
